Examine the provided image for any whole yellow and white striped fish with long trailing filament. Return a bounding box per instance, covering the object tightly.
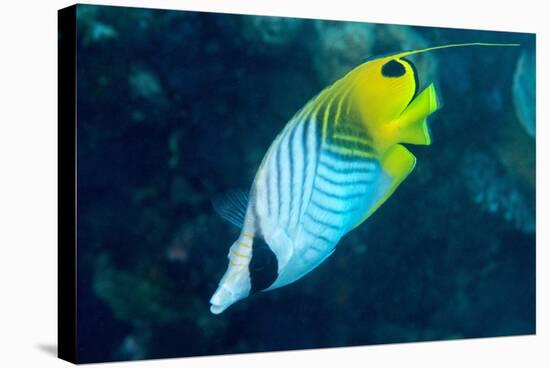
[210,43,520,314]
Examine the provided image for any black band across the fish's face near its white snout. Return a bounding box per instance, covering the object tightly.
[252,237,279,294]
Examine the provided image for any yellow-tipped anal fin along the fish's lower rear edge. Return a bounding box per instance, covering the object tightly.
[354,144,416,227]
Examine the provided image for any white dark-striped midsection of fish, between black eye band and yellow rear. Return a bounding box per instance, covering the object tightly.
[252,100,391,290]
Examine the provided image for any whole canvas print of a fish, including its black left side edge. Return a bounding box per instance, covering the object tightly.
[59,5,536,363]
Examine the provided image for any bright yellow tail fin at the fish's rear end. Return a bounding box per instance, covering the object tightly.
[396,83,440,145]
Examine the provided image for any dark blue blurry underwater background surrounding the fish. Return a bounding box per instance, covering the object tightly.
[77,5,535,362]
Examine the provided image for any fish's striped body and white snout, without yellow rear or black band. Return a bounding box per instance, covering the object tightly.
[210,77,402,314]
